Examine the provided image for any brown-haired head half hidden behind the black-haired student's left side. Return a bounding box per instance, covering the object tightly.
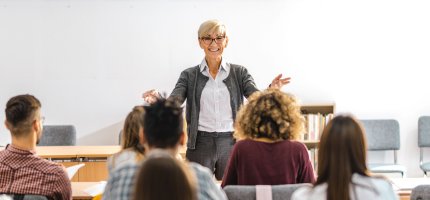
[121,106,145,154]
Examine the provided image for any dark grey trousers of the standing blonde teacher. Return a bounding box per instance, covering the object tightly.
[186,131,235,180]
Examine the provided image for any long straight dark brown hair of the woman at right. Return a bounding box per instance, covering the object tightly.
[316,115,368,200]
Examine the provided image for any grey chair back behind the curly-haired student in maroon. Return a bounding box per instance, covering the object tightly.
[224,183,311,200]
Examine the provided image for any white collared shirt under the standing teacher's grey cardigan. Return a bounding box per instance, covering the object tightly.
[198,58,234,132]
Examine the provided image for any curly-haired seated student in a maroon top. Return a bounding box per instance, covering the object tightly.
[221,89,315,187]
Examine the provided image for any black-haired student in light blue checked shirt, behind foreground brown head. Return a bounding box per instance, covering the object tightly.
[105,99,227,200]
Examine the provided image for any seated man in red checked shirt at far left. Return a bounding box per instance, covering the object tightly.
[0,94,72,200]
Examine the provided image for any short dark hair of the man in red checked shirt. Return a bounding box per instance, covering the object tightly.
[5,94,42,136]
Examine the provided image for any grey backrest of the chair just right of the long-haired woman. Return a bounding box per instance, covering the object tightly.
[360,119,400,151]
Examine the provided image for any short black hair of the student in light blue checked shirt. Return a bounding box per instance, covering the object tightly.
[143,98,183,148]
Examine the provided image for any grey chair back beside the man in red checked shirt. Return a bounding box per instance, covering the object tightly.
[38,125,76,146]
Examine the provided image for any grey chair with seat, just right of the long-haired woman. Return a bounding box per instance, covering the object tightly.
[361,119,406,178]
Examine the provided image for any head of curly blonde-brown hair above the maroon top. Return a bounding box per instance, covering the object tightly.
[234,89,304,140]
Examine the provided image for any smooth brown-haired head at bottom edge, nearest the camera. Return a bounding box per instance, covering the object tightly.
[133,151,197,200]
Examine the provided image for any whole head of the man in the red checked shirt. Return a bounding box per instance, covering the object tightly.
[5,94,43,143]
